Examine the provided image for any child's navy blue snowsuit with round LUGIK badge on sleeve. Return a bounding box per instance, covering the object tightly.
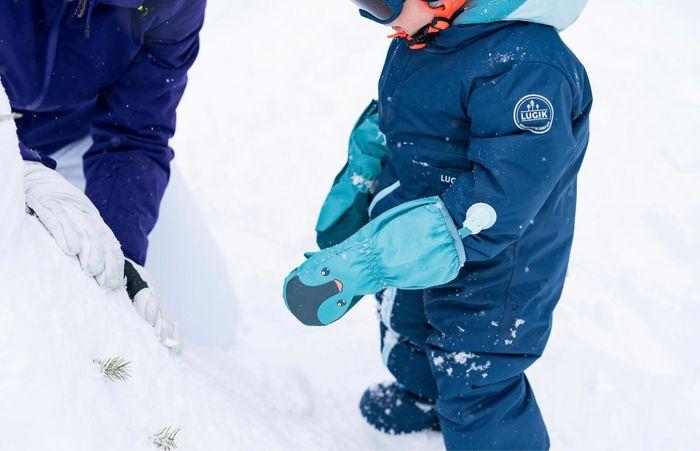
[371,22,592,449]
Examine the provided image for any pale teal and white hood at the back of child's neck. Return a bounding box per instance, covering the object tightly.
[455,0,588,31]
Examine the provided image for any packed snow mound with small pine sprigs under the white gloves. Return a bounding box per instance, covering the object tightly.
[0,84,312,451]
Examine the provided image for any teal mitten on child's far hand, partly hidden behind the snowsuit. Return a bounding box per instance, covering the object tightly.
[316,101,388,249]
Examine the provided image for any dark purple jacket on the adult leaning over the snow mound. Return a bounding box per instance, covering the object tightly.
[0,0,206,264]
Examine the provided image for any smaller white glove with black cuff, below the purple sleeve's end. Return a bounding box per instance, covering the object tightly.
[124,259,182,354]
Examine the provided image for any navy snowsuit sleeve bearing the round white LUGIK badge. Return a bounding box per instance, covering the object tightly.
[442,62,582,261]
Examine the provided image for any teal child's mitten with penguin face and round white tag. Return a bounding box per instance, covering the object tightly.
[283,197,496,326]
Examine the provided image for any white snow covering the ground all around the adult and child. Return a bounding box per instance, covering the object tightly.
[0,0,700,451]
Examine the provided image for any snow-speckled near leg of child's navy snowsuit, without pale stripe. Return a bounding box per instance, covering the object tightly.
[424,278,549,450]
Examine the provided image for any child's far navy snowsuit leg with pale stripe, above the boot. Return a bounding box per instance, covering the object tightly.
[377,288,437,402]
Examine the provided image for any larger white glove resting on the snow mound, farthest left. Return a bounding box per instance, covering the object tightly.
[24,161,124,290]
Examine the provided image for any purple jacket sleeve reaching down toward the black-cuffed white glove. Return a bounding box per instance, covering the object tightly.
[84,0,205,264]
